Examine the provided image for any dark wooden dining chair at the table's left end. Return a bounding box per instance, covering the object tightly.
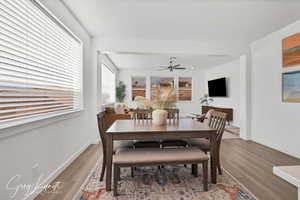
[97,112,133,181]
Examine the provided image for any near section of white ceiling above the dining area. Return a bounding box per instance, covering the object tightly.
[63,0,300,42]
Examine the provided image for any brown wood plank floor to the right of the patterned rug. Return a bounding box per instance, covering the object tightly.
[221,139,300,200]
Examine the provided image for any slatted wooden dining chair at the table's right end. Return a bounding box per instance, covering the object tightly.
[189,111,227,175]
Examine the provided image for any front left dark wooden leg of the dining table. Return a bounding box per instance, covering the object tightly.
[106,134,113,191]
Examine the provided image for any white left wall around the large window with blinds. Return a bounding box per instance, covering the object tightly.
[0,0,99,200]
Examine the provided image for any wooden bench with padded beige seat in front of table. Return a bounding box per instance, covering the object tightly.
[113,147,209,196]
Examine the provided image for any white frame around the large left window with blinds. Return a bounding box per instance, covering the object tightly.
[0,0,84,130]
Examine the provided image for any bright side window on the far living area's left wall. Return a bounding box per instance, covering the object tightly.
[101,63,116,105]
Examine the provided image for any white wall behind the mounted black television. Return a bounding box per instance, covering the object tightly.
[205,59,241,127]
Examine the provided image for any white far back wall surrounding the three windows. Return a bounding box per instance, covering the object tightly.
[119,69,205,117]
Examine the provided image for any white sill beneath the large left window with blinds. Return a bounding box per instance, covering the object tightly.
[0,109,84,139]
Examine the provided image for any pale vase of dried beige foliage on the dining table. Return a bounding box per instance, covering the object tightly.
[135,88,177,125]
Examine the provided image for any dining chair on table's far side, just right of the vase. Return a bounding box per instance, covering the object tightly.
[161,108,188,148]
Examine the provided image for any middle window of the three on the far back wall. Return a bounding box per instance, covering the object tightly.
[151,77,174,99]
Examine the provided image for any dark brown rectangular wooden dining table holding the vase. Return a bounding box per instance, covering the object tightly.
[106,119,217,191]
